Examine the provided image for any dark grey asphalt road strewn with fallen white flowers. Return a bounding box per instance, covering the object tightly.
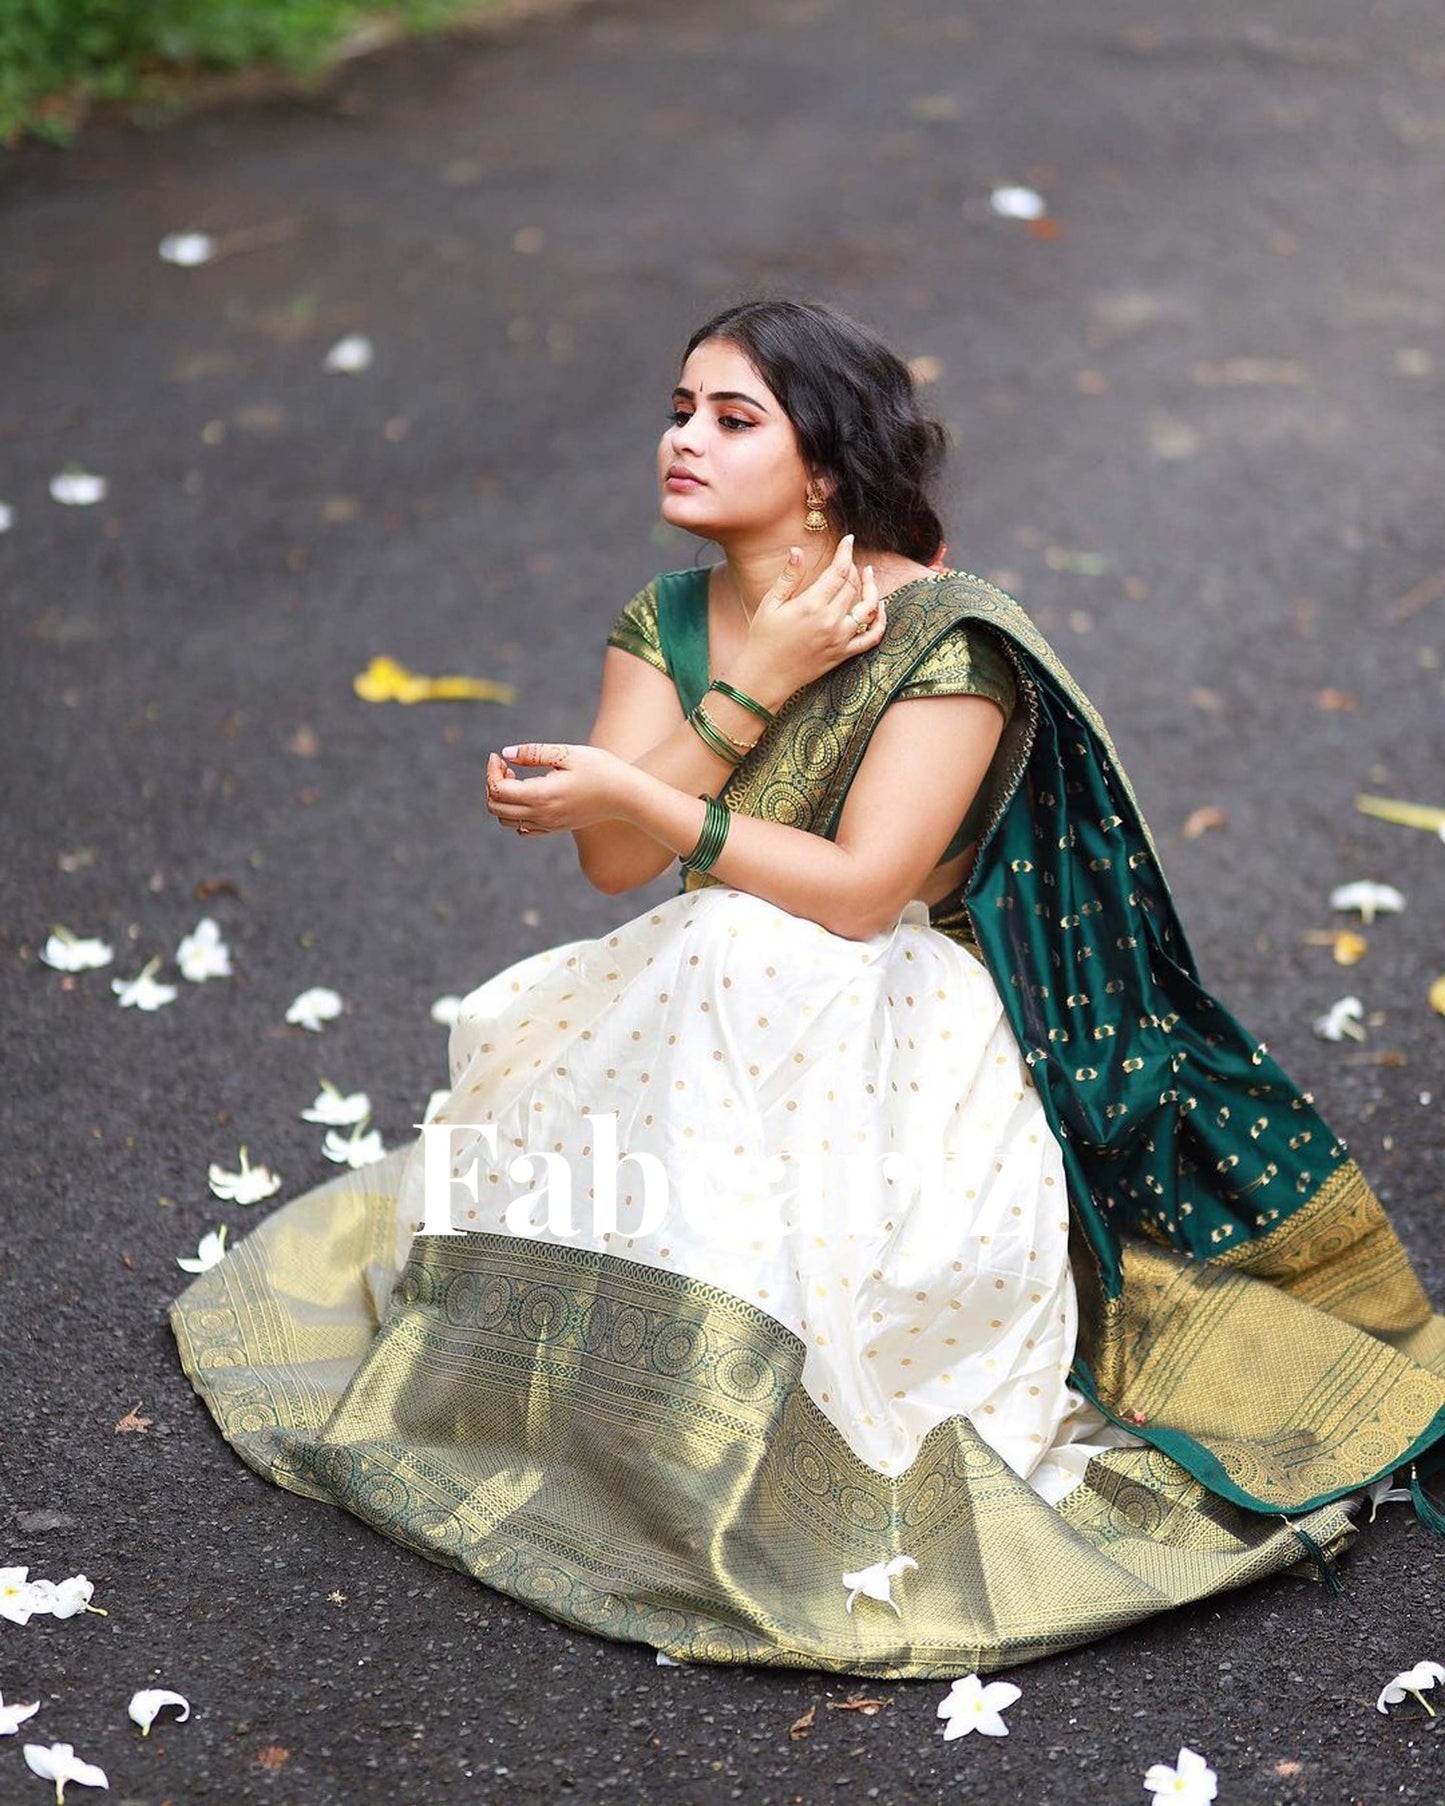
[0,0,1445,1806]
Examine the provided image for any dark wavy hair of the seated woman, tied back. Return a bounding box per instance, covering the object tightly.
[679,298,948,563]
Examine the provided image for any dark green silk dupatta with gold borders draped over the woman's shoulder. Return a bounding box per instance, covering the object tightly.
[657,571,1445,1524]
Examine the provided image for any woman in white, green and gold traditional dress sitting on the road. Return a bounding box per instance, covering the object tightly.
[172,302,1445,1678]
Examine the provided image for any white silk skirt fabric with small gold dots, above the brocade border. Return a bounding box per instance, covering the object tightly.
[397,885,1138,1503]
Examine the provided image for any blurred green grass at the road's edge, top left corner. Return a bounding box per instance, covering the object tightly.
[0,0,520,148]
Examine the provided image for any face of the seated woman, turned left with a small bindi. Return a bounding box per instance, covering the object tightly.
[657,340,825,542]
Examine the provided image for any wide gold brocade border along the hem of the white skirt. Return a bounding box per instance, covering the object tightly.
[172,1156,1349,1680]
